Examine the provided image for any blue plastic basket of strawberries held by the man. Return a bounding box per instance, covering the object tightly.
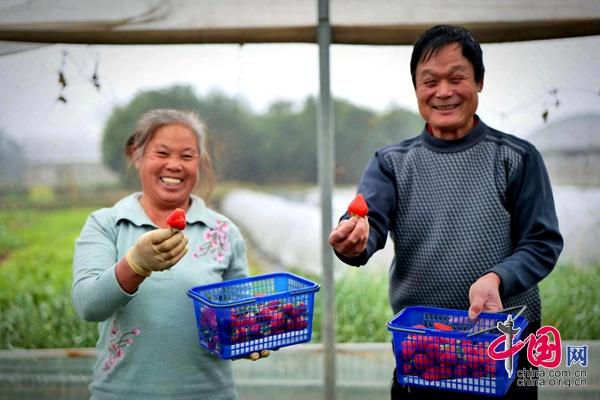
[387,307,527,396]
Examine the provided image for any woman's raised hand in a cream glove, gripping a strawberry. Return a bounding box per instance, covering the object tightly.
[126,228,188,277]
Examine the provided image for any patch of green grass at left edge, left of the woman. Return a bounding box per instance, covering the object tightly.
[0,208,97,349]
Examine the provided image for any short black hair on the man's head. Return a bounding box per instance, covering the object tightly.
[410,25,485,87]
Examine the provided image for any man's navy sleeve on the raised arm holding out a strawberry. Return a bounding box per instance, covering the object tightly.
[335,151,396,266]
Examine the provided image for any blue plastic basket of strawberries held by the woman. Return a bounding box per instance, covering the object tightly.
[187,272,320,359]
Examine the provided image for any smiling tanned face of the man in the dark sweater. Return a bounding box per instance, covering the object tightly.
[415,43,483,139]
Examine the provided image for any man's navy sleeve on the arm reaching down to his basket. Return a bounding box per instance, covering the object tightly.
[488,146,563,297]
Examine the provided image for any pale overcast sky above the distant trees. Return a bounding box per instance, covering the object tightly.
[0,36,600,161]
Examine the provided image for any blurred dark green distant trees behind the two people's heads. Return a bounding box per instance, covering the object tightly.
[102,86,423,183]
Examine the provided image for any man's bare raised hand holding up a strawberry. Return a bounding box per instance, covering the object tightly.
[329,217,369,258]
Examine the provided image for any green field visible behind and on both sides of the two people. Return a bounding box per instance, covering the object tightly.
[0,208,600,349]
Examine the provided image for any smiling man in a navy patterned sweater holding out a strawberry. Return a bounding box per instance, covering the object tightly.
[329,25,563,399]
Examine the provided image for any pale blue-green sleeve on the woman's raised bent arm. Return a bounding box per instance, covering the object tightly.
[71,210,135,322]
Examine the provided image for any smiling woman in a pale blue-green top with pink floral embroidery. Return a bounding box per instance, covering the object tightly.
[72,110,260,399]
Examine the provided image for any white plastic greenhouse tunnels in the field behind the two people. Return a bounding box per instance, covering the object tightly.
[221,186,600,275]
